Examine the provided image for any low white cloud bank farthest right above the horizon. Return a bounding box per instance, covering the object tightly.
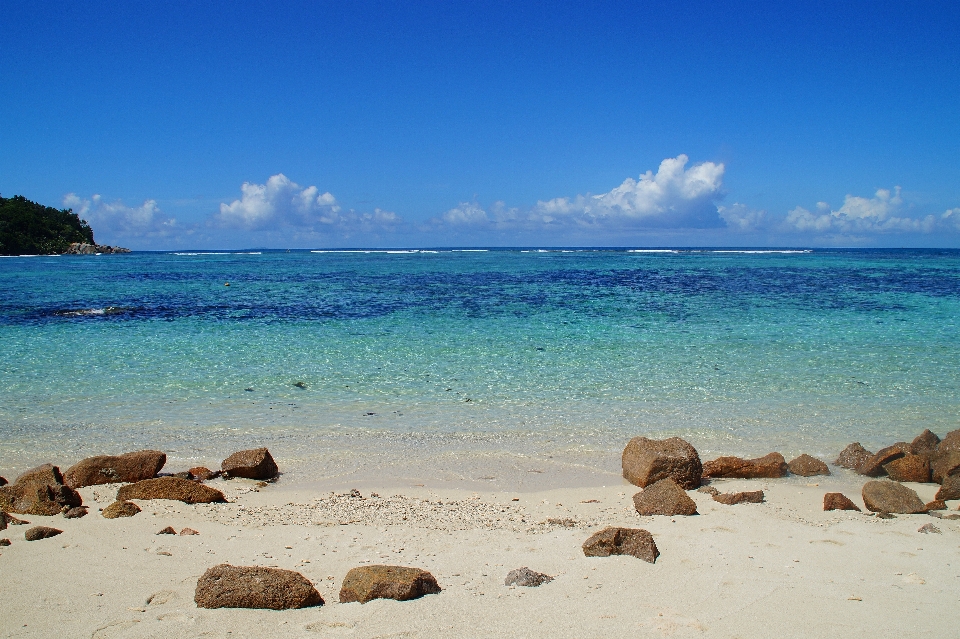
[784,186,932,234]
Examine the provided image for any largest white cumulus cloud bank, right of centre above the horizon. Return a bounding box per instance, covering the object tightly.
[433,155,728,230]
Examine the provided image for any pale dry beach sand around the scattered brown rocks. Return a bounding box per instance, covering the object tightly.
[0,471,960,639]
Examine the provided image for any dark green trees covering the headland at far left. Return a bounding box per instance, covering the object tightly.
[0,195,94,255]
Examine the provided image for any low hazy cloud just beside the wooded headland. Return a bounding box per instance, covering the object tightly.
[63,193,182,241]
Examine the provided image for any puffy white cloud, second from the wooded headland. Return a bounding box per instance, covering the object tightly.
[212,173,401,232]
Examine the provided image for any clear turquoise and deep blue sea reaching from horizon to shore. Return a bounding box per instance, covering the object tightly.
[0,250,960,480]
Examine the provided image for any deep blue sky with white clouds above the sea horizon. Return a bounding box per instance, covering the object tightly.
[0,0,960,249]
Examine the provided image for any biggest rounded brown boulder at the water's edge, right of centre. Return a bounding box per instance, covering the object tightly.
[621,437,703,490]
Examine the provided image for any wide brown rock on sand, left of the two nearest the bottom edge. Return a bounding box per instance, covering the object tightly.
[193,564,323,610]
